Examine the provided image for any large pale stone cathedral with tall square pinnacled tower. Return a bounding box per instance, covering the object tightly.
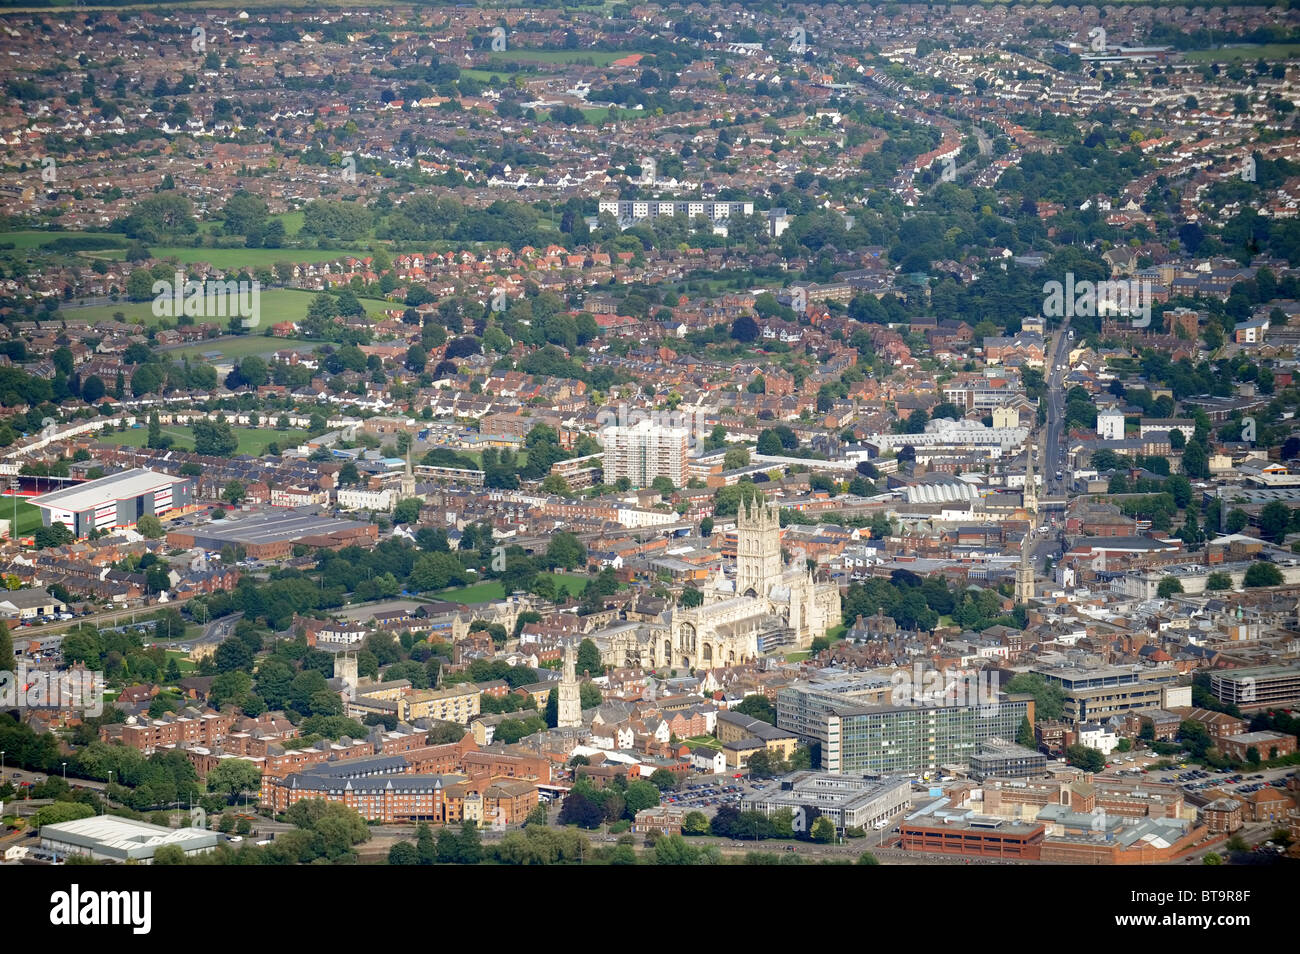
[592,499,841,671]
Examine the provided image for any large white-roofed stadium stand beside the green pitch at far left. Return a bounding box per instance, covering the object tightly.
[31,467,190,538]
